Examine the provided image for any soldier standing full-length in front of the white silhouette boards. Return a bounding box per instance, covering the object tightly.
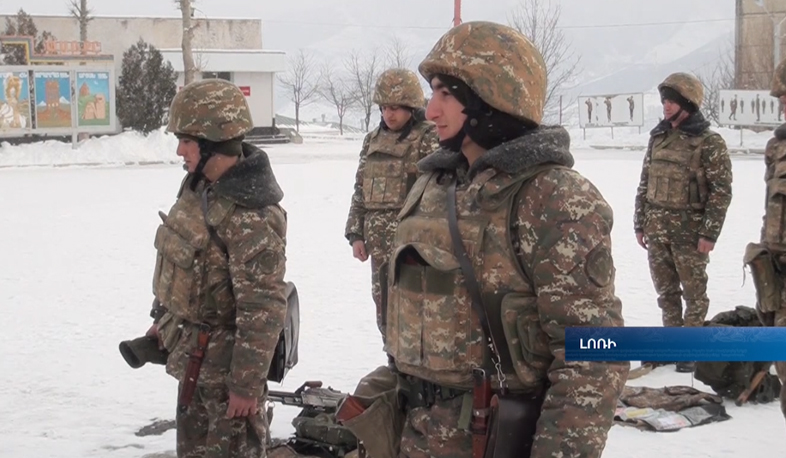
[633,73,732,372]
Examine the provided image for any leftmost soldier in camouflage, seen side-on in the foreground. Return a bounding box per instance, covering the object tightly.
[148,79,287,458]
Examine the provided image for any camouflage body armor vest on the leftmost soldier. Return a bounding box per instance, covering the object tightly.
[153,183,235,332]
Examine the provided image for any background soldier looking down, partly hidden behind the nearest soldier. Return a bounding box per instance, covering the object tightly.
[344,68,439,341]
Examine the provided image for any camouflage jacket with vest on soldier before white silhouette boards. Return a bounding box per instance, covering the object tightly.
[633,112,732,245]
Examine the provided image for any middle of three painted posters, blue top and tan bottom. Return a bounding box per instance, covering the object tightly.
[33,72,72,129]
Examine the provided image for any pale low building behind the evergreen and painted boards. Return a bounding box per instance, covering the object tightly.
[0,15,286,134]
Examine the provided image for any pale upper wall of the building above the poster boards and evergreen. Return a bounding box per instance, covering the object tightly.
[0,15,262,76]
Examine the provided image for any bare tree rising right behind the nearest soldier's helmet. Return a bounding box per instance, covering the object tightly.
[508,0,581,122]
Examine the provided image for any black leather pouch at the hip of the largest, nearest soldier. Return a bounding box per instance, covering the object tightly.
[484,393,544,458]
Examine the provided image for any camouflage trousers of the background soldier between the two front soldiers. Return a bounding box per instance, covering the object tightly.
[364,210,398,341]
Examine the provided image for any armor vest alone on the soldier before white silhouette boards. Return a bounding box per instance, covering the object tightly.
[647,130,714,210]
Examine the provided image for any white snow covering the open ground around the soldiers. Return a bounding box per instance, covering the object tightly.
[0,131,786,458]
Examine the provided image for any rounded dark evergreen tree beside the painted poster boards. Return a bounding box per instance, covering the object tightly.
[116,39,177,134]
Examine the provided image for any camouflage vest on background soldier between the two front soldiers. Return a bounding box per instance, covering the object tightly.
[363,123,427,210]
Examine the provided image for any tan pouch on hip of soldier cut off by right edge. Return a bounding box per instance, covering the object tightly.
[743,243,783,326]
